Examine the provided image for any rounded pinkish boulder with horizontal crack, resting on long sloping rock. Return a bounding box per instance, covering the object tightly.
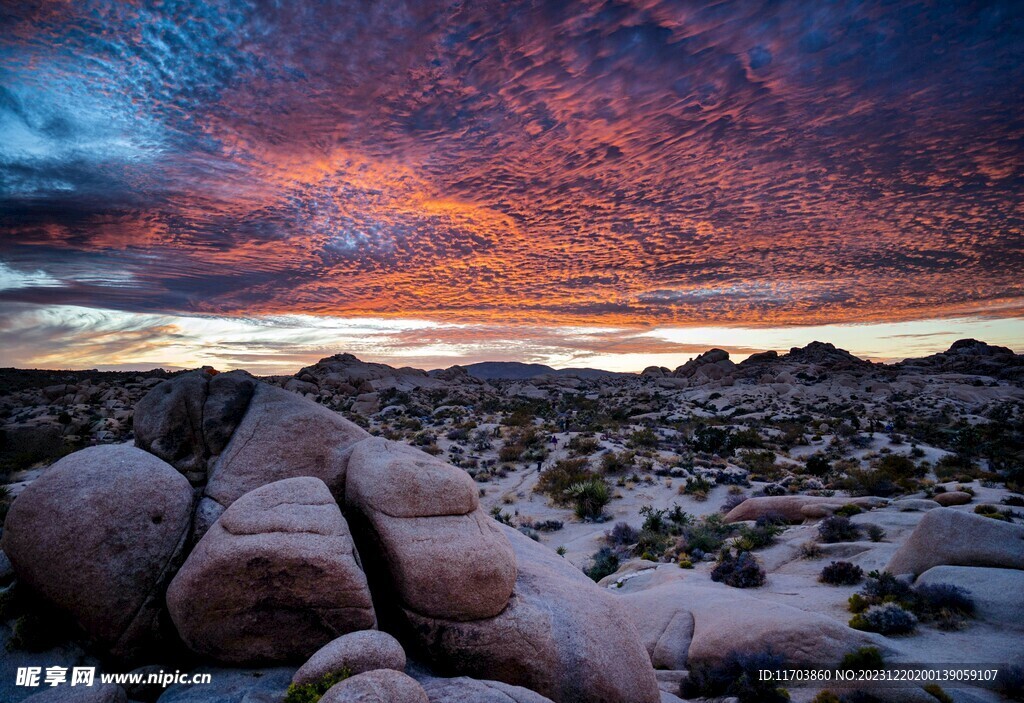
[345,438,516,620]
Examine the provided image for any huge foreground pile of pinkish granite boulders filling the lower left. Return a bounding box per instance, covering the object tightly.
[0,371,660,703]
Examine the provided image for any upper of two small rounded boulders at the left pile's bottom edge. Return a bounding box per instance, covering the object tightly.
[292,629,406,685]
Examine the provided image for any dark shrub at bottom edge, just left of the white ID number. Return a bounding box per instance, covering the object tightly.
[679,650,790,703]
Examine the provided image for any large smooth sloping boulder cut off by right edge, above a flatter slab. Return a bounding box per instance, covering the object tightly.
[886,508,1024,576]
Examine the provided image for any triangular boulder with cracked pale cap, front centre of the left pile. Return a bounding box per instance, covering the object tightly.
[167,477,376,663]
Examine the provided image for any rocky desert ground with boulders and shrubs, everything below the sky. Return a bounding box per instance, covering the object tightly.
[0,340,1024,703]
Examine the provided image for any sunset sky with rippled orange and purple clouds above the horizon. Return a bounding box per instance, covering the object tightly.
[0,0,1024,372]
